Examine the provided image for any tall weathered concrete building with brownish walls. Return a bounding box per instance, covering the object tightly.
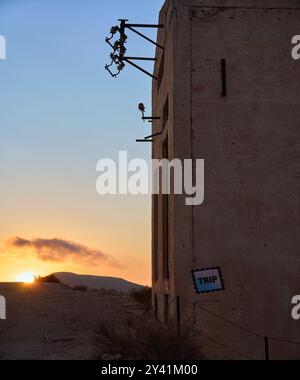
[153,0,300,359]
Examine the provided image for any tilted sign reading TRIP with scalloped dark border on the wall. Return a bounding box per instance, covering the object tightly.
[192,267,225,294]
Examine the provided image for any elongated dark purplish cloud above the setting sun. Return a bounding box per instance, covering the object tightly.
[7,236,121,267]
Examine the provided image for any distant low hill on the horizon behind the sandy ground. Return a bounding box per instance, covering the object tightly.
[53,272,143,293]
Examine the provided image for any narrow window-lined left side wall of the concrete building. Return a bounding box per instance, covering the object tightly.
[152,2,175,320]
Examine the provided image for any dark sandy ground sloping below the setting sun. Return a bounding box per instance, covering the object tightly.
[0,283,148,360]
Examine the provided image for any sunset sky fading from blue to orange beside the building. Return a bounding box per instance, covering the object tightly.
[0,0,163,284]
